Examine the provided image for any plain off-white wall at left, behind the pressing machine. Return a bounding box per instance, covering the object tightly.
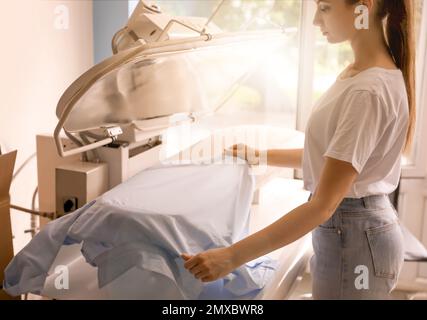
[0,0,93,251]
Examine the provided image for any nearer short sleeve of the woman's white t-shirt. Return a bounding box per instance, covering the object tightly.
[323,91,390,174]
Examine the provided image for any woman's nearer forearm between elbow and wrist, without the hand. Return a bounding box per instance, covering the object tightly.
[229,201,331,268]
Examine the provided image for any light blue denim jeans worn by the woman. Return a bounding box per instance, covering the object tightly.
[309,195,404,299]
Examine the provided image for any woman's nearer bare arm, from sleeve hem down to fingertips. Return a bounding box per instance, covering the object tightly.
[182,157,357,282]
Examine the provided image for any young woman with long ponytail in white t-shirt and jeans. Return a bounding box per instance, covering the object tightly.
[182,0,415,299]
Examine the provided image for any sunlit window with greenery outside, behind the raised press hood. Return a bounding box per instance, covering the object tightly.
[140,0,301,128]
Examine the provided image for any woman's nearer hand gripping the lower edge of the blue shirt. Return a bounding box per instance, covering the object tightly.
[181,247,237,282]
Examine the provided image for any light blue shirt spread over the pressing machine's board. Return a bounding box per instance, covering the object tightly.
[4,164,275,299]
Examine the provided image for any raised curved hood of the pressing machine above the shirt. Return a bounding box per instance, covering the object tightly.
[56,31,283,132]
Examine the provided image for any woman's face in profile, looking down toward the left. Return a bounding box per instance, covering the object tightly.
[313,0,357,43]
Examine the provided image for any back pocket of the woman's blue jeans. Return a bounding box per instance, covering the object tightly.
[366,220,404,280]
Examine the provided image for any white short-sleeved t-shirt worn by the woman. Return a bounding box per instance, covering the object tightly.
[303,67,409,198]
